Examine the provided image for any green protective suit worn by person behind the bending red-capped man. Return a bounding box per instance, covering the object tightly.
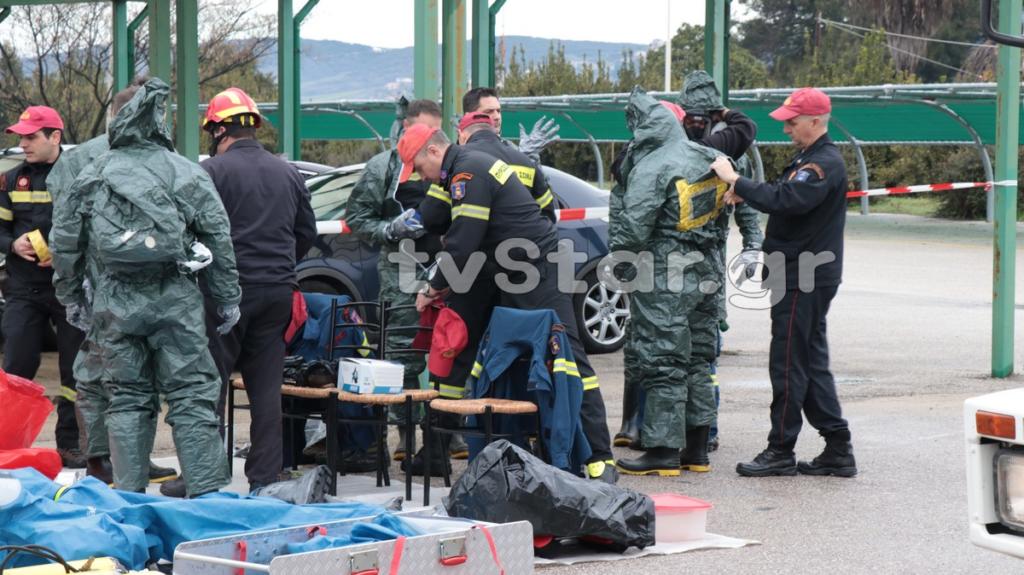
[345,105,429,405]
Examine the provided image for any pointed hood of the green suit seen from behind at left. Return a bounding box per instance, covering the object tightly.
[109,78,174,151]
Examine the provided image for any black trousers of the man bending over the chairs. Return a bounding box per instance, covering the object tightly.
[438,262,612,461]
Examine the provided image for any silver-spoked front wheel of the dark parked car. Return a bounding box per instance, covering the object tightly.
[573,270,630,353]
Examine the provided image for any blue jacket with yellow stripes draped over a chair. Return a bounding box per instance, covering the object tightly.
[467,307,591,473]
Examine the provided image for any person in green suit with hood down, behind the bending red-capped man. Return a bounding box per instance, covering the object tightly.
[345,98,441,466]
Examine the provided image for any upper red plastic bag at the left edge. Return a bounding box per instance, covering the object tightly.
[0,370,53,449]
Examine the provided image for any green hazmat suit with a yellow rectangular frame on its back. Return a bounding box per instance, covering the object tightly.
[608,88,726,448]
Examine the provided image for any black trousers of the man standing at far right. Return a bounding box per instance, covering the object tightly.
[768,286,849,451]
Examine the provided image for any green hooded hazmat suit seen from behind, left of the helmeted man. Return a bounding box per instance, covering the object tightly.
[51,79,242,495]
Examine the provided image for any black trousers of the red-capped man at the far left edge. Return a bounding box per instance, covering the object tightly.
[3,280,85,449]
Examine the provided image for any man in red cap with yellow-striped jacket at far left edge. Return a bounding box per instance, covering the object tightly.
[0,105,85,468]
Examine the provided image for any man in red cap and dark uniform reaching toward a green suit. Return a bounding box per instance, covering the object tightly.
[711,88,857,477]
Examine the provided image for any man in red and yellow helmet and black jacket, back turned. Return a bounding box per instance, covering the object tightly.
[202,88,316,489]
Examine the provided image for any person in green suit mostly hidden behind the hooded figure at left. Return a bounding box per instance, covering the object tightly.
[46,81,177,483]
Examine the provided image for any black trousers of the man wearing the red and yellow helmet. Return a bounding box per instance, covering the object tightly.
[206,285,292,485]
